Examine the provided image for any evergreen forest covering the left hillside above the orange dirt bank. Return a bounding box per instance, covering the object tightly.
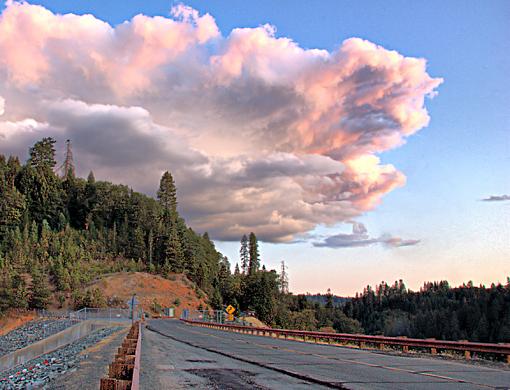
[0,138,277,311]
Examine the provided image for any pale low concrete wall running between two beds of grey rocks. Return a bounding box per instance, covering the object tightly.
[0,320,127,372]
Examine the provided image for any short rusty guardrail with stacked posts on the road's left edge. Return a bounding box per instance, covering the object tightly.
[99,321,142,390]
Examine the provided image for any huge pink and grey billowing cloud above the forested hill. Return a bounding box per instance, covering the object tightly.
[0,2,441,241]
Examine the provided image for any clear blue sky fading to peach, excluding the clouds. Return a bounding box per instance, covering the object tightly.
[1,0,510,295]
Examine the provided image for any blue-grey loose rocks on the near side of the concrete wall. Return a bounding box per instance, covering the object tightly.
[0,327,122,390]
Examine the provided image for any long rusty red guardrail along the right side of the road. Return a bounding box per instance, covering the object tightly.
[181,320,510,364]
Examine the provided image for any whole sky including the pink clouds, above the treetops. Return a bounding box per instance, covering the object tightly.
[0,0,510,295]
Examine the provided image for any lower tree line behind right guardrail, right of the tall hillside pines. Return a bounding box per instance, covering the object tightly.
[262,278,510,343]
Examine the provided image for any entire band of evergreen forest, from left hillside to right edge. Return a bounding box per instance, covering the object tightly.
[0,138,510,342]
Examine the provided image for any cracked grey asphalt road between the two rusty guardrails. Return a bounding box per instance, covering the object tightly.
[140,320,510,389]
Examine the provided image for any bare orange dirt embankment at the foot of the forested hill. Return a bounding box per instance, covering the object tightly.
[87,272,207,317]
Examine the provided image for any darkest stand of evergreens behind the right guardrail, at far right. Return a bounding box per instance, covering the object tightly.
[343,278,510,343]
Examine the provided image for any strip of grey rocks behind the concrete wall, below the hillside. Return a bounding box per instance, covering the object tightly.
[0,319,76,356]
